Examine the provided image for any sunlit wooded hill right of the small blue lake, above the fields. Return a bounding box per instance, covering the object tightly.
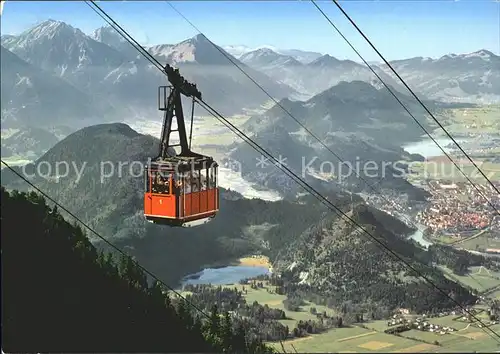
[277,205,476,313]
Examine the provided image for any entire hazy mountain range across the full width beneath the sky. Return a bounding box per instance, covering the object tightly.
[1,20,500,137]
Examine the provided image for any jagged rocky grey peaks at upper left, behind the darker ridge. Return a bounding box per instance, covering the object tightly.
[2,20,294,119]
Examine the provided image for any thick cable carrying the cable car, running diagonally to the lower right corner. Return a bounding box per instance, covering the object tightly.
[84,2,500,341]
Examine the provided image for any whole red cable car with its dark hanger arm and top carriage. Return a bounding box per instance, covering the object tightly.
[144,64,219,227]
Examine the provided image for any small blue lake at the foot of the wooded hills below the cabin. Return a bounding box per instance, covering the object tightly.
[182,266,269,285]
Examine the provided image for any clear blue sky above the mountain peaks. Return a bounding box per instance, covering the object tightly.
[1,0,500,61]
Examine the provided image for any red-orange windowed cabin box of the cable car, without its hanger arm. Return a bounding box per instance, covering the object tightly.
[144,158,219,226]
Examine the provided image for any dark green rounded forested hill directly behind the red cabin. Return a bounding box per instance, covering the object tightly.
[2,124,332,282]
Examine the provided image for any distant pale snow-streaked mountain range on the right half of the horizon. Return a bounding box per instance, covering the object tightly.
[239,47,500,103]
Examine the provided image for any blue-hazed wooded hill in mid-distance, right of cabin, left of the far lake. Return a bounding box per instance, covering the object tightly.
[231,81,438,200]
